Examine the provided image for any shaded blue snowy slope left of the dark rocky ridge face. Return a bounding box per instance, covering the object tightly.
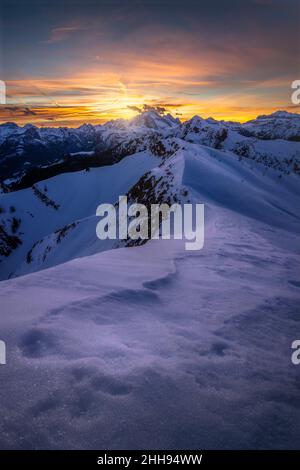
[0,153,157,279]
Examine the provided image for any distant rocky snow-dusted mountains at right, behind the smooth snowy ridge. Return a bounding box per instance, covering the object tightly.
[177,113,300,174]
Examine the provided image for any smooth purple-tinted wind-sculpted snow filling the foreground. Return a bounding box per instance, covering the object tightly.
[0,208,300,449]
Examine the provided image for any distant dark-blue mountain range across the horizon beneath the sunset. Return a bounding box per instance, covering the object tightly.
[0,111,300,191]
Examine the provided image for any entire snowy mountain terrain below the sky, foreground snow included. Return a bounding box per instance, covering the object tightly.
[0,112,300,449]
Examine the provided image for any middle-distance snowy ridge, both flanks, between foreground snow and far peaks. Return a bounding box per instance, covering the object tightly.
[0,129,300,279]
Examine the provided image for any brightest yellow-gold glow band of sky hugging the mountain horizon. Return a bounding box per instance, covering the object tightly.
[0,72,299,127]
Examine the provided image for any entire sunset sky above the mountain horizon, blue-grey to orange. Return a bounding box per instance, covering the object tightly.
[0,0,300,126]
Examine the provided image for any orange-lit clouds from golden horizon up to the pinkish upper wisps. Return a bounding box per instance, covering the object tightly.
[0,26,294,126]
